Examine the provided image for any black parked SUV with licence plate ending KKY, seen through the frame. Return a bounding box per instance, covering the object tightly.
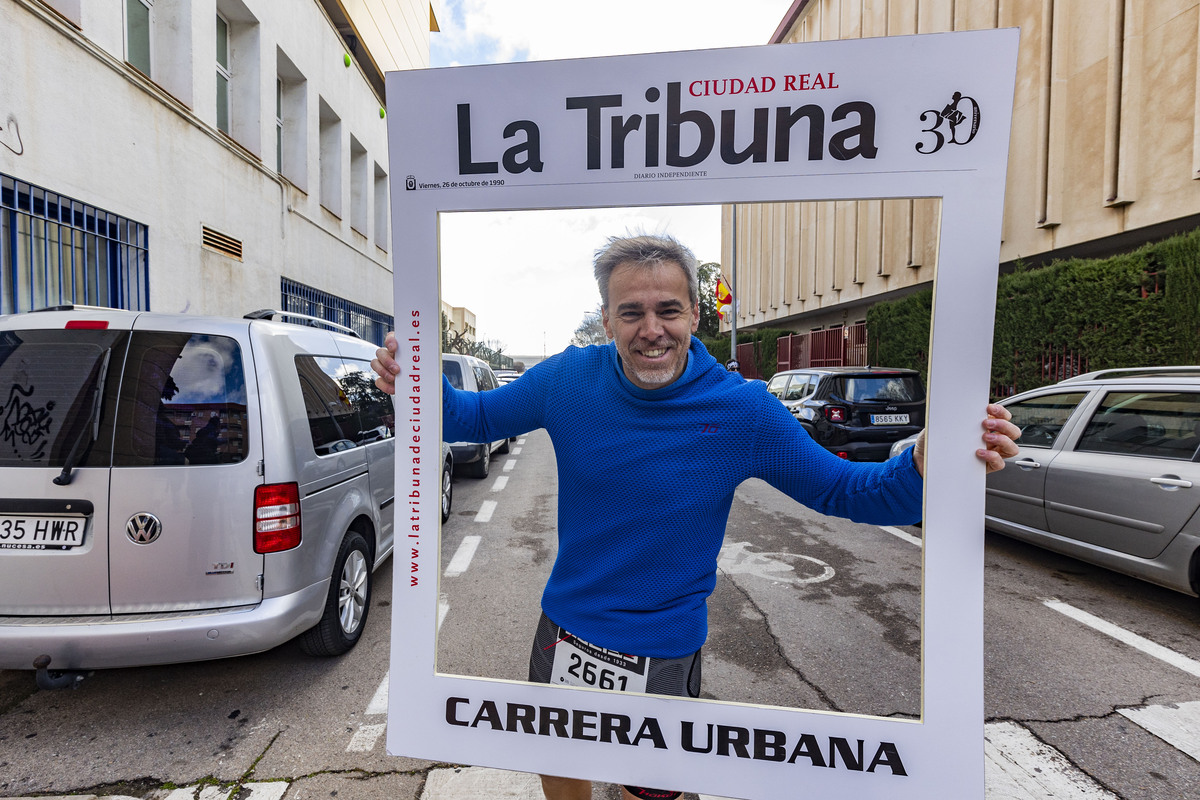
[767,367,925,461]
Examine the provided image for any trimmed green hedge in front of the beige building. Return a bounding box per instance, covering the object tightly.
[866,230,1200,391]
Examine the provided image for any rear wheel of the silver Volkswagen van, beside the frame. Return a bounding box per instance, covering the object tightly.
[300,530,371,656]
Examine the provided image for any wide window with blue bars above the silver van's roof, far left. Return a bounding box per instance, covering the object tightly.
[0,173,150,314]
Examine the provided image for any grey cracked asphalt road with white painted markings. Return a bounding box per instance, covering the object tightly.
[0,433,1200,800]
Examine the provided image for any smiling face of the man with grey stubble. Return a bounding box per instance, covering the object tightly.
[602,261,700,389]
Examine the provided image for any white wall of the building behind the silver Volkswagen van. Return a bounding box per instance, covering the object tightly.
[0,0,428,331]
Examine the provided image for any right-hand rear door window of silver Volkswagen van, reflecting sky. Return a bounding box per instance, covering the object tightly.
[113,331,247,467]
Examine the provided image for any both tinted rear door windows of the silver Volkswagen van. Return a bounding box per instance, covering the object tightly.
[0,329,248,467]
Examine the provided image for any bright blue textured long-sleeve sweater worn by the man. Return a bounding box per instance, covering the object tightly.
[442,338,922,658]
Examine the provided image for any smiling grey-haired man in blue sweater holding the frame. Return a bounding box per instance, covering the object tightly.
[372,235,1020,800]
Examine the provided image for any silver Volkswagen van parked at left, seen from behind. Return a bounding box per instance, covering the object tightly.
[0,306,396,675]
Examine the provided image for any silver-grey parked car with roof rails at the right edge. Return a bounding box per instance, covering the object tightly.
[986,367,1200,595]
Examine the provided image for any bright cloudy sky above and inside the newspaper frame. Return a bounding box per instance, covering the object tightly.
[430,0,791,356]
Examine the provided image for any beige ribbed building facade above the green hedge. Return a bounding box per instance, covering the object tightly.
[722,0,1200,332]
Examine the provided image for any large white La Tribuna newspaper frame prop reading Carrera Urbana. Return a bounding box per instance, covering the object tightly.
[388,30,1018,800]
